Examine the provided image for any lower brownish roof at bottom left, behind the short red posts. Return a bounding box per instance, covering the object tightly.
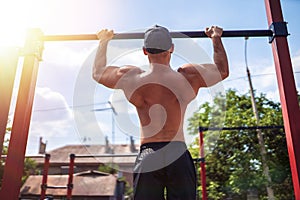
[20,171,117,196]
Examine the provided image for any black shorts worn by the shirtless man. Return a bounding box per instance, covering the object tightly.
[133,142,196,200]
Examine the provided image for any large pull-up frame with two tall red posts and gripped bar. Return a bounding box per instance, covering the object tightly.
[0,0,300,200]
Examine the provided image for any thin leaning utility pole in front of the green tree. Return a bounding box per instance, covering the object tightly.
[245,37,275,200]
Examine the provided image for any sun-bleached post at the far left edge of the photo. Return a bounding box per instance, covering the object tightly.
[0,48,19,157]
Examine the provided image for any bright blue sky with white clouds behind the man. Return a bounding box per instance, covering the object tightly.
[0,0,300,154]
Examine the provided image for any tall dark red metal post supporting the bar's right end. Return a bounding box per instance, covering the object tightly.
[265,0,300,200]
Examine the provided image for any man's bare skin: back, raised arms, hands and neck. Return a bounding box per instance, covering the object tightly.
[93,26,229,143]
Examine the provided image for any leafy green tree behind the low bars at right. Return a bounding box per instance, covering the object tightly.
[188,90,293,200]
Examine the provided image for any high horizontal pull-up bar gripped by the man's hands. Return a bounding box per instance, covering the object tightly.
[41,30,273,41]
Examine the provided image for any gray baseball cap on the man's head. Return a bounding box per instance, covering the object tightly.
[144,25,172,54]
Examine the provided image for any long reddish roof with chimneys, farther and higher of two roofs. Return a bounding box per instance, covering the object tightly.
[32,144,139,165]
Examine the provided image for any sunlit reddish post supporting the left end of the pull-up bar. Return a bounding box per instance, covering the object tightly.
[0,29,43,199]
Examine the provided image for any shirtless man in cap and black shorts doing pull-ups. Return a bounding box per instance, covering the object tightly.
[93,25,229,200]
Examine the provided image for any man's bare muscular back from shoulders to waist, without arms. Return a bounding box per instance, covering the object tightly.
[118,66,196,144]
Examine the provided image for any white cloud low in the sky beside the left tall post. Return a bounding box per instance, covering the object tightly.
[27,87,78,153]
